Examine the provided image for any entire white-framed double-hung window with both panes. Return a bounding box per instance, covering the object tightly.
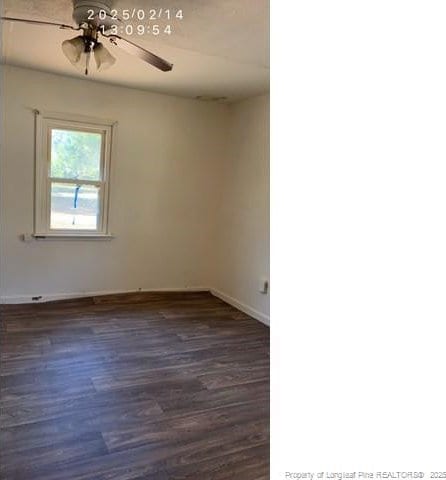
[34,113,114,237]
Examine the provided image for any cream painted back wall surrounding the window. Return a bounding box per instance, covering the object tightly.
[0,66,229,301]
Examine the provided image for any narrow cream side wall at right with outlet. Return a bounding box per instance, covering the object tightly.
[212,95,269,323]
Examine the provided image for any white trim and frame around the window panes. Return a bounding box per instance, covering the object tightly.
[34,111,117,239]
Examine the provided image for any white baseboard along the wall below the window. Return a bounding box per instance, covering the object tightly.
[0,287,210,305]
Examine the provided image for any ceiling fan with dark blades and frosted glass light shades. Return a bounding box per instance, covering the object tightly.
[0,0,173,75]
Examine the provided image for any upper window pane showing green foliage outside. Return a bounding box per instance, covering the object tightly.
[51,129,102,180]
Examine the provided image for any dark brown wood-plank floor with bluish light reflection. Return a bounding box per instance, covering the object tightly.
[0,293,269,480]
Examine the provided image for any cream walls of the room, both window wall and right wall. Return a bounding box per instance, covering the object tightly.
[0,66,269,321]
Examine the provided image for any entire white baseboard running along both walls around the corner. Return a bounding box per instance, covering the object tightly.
[0,287,269,326]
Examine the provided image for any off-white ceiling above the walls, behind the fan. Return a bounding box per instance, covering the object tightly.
[2,0,269,101]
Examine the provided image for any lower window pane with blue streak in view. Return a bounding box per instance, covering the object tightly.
[51,183,99,230]
